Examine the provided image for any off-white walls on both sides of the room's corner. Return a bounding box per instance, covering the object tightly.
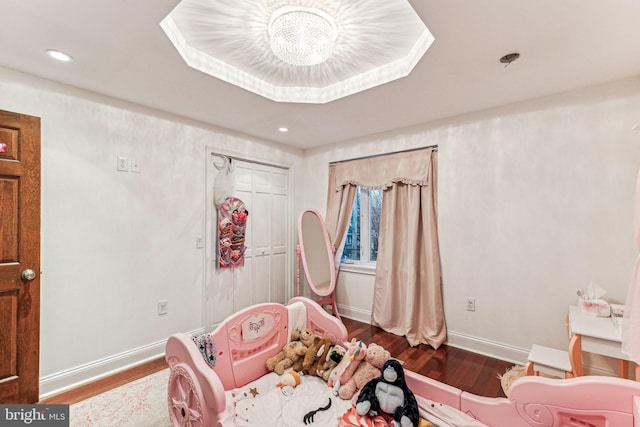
[0,64,640,394]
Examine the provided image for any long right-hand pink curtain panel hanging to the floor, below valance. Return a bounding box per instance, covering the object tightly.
[371,150,447,348]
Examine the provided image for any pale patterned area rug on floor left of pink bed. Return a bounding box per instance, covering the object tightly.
[69,369,171,427]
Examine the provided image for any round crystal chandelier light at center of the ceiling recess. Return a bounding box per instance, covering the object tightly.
[269,6,338,66]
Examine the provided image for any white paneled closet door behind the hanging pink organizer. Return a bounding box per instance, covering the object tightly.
[204,155,296,330]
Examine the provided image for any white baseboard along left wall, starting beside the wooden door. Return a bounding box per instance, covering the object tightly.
[40,328,204,400]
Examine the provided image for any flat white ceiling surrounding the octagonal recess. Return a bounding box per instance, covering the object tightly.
[0,0,640,149]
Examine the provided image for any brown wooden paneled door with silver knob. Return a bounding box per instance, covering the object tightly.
[0,110,40,403]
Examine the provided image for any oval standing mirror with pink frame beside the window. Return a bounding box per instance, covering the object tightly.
[298,209,336,297]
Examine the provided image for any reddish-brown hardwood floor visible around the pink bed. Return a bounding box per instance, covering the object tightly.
[40,318,513,404]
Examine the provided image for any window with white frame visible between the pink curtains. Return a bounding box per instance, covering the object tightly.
[342,187,382,263]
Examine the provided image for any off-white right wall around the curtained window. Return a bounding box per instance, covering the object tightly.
[304,78,640,370]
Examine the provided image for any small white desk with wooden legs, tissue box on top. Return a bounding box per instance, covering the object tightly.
[569,305,640,379]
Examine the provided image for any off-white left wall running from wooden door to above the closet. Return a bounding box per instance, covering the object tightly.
[0,68,301,395]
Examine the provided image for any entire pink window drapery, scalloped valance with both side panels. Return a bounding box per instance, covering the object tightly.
[326,148,446,348]
